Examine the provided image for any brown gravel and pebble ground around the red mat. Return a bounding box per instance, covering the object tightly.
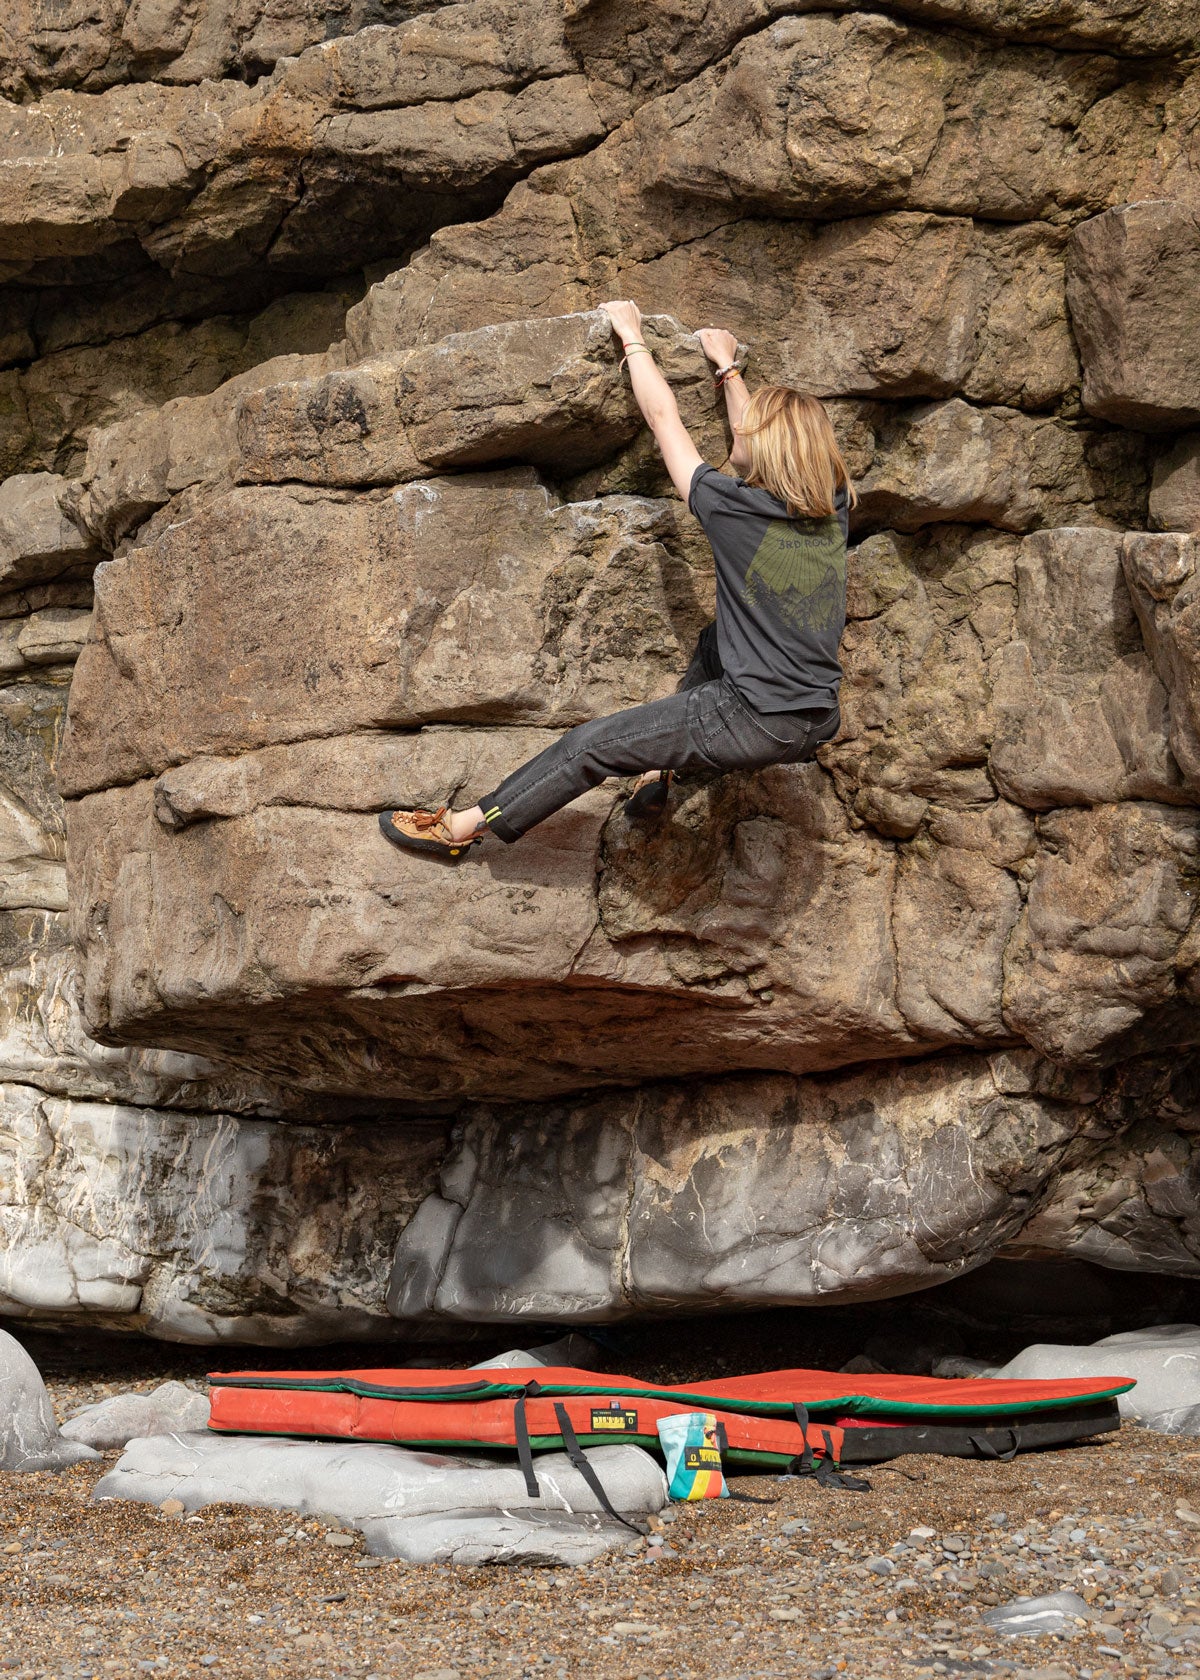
[0,1347,1200,1680]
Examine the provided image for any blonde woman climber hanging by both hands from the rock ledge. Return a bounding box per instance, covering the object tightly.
[380,302,855,862]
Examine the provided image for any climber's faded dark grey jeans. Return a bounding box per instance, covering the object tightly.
[479,625,840,842]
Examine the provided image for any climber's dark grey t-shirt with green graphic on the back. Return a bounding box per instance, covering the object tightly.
[687,464,849,712]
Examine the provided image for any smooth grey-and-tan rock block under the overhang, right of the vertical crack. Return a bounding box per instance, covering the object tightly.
[390,1055,1188,1319]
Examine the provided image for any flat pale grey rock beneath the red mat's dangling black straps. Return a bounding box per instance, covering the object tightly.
[94,1435,667,1562]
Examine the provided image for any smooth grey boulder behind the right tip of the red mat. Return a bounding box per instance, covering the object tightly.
[982,1324,1200,1435]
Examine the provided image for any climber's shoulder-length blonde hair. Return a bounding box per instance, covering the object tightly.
[738,385,857,519]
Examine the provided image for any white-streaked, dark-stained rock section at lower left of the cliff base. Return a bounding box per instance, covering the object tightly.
[0,1085,445,1346]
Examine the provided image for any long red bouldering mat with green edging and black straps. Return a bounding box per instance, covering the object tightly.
[208,1366,1133,1467]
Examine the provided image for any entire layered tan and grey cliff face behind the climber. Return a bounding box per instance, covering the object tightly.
[0,0,1200,1342]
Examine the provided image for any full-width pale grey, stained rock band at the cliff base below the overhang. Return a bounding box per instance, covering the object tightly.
[0,1053,1200,1346]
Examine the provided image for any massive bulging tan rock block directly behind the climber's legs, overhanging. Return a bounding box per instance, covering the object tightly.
[61,436,1193,1102]
